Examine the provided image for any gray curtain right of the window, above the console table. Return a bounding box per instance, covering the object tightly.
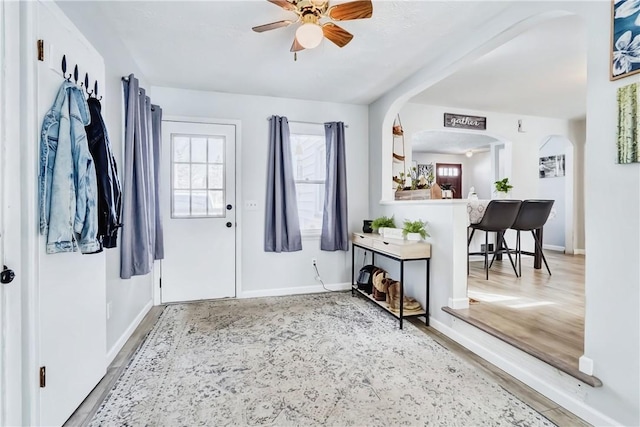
[320,122,349,251]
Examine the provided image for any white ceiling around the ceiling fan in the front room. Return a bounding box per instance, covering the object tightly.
[59,0,506,104]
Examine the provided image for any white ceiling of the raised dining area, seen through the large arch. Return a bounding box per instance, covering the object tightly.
[411,15,587,119]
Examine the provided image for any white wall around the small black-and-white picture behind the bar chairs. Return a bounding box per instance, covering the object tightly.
[539,136,573,249]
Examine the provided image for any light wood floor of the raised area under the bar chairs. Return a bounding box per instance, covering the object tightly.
[455,250,584,378]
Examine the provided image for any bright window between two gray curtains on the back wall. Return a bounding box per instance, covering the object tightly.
[289,123,327,235]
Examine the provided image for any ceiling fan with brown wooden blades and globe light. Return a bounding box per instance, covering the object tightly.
[253,0,373,52]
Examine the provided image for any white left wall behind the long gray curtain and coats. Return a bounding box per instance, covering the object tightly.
[58,2,155,359]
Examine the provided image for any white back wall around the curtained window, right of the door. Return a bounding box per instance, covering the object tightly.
[151,87,369,297]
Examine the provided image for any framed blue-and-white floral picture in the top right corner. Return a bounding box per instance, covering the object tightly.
[610,0,640,80]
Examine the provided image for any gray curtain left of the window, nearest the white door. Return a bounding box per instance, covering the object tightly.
[264,116,302,252]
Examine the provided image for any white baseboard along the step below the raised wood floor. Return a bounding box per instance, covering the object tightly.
[429,317,622,426]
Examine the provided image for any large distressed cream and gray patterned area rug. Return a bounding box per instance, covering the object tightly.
[90,292,553,426]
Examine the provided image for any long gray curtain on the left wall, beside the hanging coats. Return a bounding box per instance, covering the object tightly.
[120,74,162,279]
